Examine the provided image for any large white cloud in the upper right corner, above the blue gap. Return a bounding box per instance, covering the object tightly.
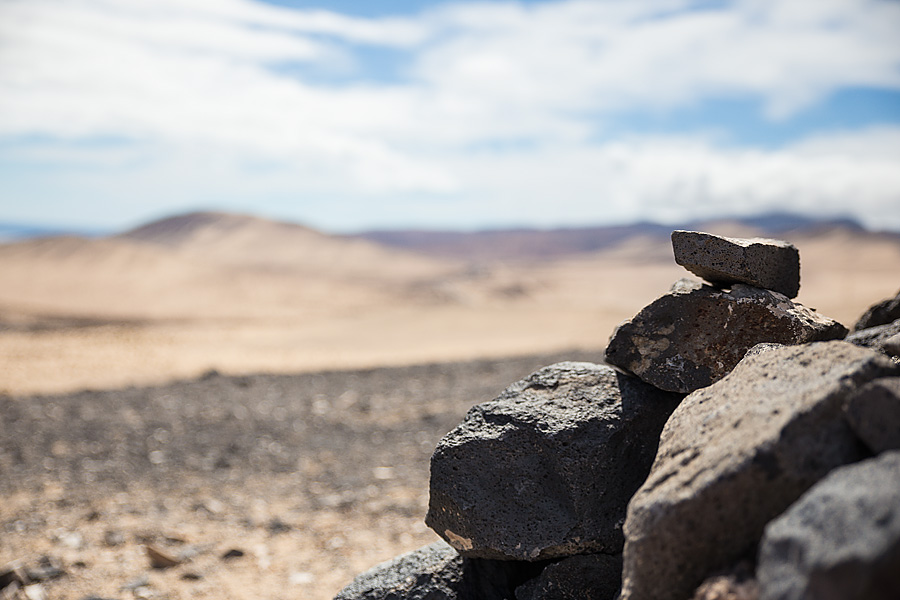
[418,0,900,125]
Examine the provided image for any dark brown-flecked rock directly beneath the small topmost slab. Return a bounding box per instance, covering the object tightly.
[606,282,847,393]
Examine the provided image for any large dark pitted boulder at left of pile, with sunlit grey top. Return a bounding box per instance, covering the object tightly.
[425,362,681,561]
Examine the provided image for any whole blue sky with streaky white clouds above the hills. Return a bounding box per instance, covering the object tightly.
[0,0,900,232]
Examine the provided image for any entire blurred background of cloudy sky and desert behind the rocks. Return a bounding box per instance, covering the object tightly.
[0,0,900,600]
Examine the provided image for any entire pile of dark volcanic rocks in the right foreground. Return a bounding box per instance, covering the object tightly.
[336,231,900,600]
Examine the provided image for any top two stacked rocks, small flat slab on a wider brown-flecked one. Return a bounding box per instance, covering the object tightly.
[606,231,847,394]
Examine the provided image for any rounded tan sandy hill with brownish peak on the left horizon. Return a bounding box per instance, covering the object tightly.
[0,213,460,330]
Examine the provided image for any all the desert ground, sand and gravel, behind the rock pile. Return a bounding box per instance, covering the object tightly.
[0,213,900,600]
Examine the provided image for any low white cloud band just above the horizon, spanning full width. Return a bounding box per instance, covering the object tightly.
[0,127,900,231]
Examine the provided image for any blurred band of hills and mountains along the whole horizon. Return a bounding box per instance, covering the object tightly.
[0,211,900,266]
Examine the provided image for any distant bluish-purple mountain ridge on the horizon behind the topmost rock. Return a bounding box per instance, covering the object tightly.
[357,213,872,261]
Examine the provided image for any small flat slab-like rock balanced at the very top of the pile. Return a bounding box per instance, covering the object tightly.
[672,231,800,298]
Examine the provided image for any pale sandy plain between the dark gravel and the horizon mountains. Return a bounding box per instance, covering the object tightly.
[0,216,900,395]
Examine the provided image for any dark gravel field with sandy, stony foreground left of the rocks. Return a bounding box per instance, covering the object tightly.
[0,351,599,600]
